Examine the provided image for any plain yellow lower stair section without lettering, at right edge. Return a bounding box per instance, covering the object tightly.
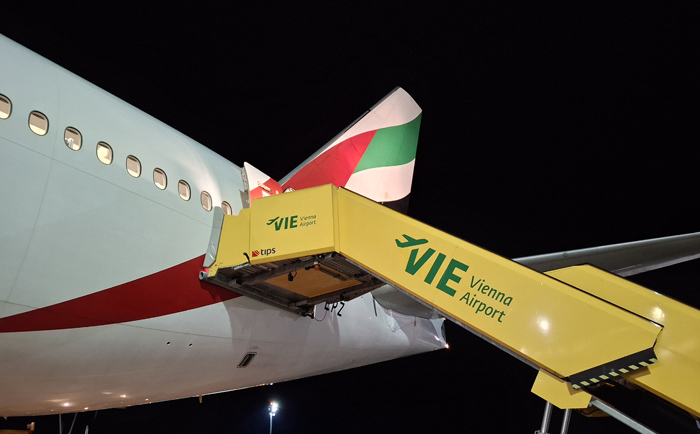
[548,266,700,417]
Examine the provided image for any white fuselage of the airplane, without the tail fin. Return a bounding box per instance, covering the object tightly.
[0,36,445,416]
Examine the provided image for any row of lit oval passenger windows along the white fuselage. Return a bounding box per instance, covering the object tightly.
[0,94,233,215]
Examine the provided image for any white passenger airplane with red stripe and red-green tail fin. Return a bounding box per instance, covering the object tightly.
[0,32,700,432]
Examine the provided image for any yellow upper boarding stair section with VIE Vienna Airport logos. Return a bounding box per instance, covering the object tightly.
[201,185,700,416]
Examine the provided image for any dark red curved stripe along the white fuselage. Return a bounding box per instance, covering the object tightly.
[0,256,239,333]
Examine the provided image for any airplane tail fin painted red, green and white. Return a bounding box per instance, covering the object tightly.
[246,87,422,211]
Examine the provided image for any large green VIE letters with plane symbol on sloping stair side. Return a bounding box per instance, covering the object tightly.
[395,234,469,297]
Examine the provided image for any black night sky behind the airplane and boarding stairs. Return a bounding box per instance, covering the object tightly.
[0,1,700,433]
